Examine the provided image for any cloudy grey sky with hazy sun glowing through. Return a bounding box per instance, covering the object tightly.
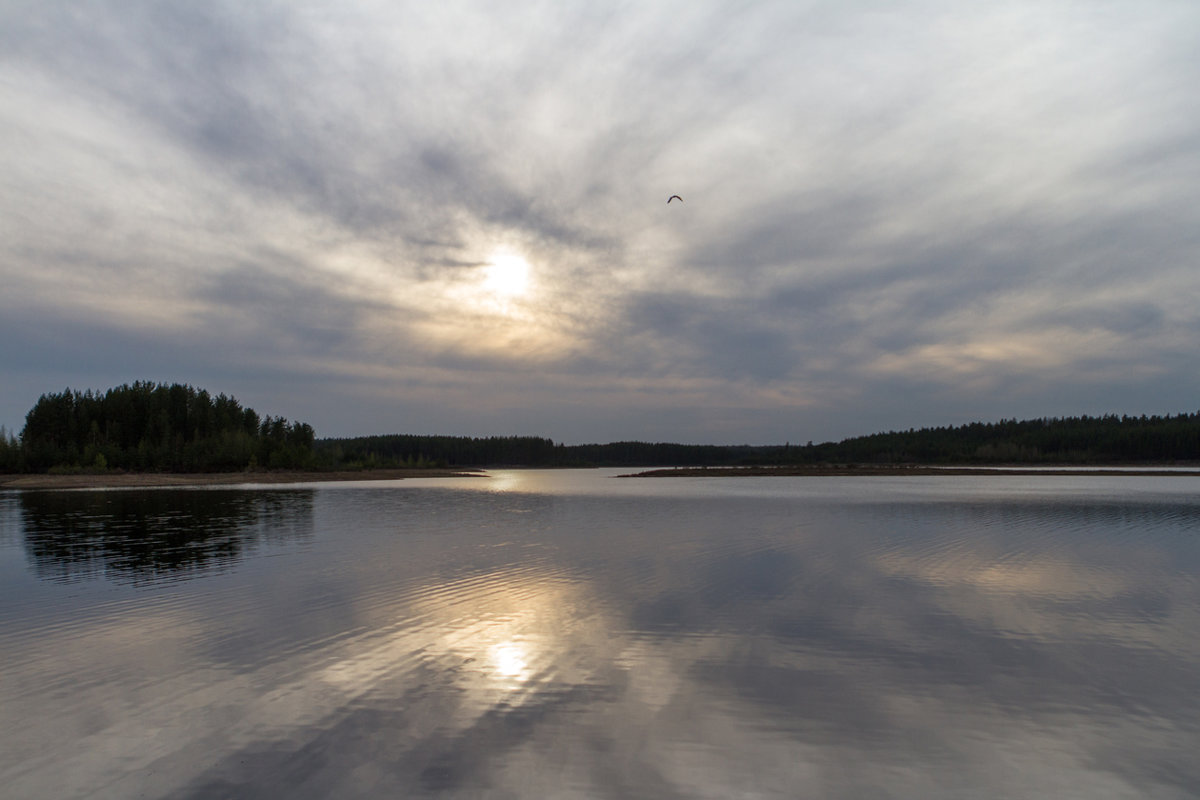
[0,0,1200,444]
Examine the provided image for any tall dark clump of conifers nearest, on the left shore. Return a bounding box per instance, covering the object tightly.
[0,381,314,473]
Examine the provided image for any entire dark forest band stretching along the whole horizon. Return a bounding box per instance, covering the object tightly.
[0,381,1200,473]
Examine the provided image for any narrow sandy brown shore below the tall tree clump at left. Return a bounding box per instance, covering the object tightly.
[0,469,485,489]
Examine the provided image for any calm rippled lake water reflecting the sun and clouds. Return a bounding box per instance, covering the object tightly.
[0,470,1200,800]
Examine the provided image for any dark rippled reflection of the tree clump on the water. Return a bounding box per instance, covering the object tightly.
[20,489,313,584]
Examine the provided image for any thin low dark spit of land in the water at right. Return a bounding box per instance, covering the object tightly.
[619,464,1200,477]
